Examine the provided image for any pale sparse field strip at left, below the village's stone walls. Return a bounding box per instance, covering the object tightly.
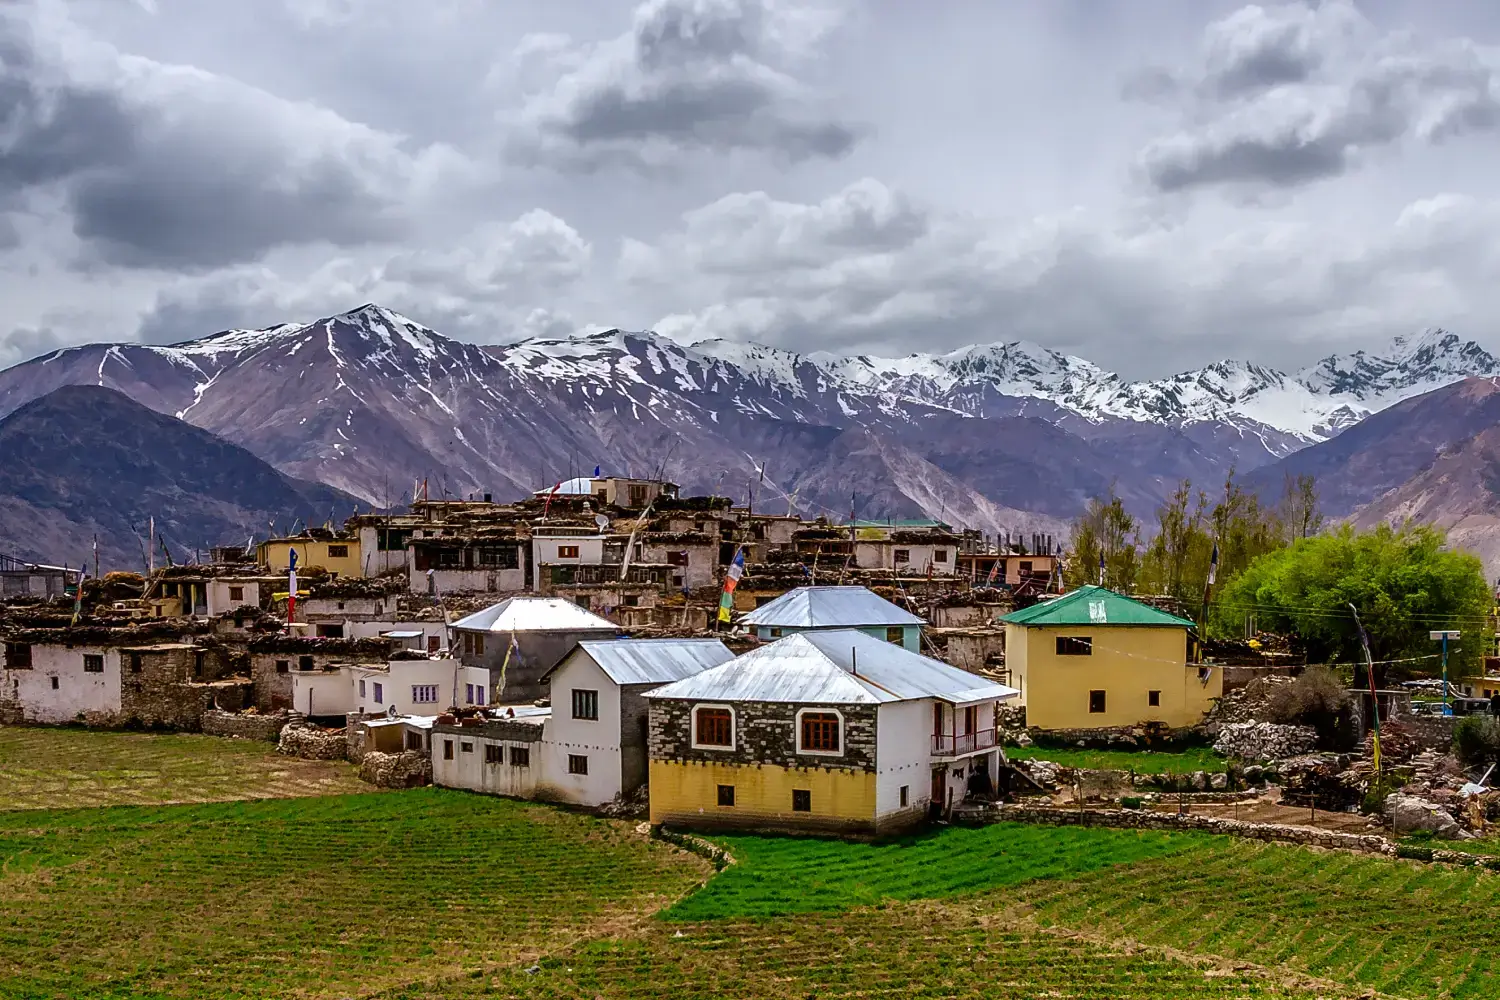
[0,726,369,811]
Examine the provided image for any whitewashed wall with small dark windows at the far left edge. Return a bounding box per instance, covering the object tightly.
[0,643,120,723]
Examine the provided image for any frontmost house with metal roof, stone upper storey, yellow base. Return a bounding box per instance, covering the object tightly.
[644,630,1016,835]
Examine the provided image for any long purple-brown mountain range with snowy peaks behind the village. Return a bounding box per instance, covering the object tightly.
[0,304,1500,569]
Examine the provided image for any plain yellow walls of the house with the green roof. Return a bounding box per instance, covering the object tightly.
[1005,625,1224,729]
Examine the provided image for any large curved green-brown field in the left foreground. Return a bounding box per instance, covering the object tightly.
[0,789,708,1000]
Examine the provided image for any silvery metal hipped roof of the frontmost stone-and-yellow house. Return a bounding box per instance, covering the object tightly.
[645,630,1019,705]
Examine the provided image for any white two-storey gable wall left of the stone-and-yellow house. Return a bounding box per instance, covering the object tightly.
[540,651,624,807]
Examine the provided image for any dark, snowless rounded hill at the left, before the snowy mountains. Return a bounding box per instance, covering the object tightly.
[0,385,357,570]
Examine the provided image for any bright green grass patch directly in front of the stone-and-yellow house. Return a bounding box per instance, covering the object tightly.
[663,823,1211,921]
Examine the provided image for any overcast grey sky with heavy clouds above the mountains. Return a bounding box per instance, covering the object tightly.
[0,0,1500,378]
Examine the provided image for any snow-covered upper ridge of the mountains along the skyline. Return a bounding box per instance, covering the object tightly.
[143,304,1500,451]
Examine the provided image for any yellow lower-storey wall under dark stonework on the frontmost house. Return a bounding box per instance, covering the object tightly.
[651,760,875,832]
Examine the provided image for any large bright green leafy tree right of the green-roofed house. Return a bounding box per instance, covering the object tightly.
[1211,525,1494,685]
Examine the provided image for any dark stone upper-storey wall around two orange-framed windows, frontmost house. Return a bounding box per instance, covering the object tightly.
[647,699,875,771]
